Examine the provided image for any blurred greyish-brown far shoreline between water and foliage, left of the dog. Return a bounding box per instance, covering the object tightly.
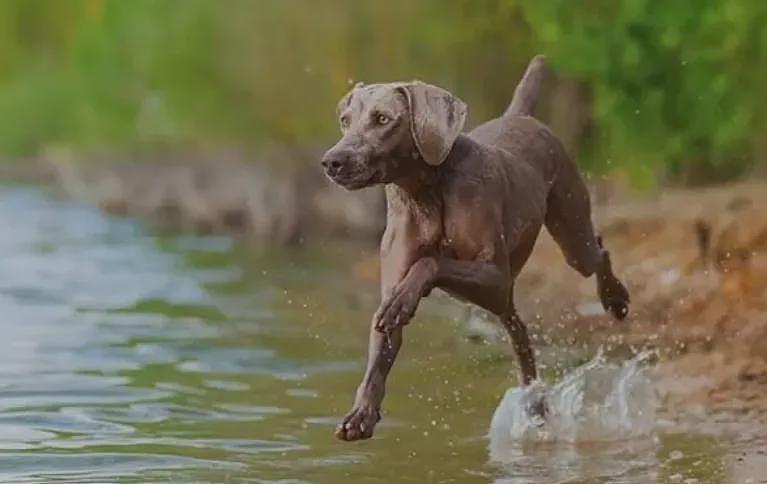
[0,150,385,246]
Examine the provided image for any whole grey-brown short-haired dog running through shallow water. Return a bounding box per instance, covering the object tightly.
[322,57,629,440]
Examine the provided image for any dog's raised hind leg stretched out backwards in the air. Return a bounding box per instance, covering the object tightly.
[545,155,629,319]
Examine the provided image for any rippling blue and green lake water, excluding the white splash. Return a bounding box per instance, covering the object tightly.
[0,187,752,483]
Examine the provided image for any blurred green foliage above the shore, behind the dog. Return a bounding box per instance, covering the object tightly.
[0,0,767,184]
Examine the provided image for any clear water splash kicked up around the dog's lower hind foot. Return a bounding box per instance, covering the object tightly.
[489,350,656,460]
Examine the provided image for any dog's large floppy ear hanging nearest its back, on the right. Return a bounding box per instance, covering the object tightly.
[399,82,466,165]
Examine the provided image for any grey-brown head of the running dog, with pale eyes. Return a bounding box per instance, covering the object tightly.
[322,82,466,190]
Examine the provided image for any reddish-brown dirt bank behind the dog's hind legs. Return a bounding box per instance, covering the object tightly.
[540,184,767,413]
